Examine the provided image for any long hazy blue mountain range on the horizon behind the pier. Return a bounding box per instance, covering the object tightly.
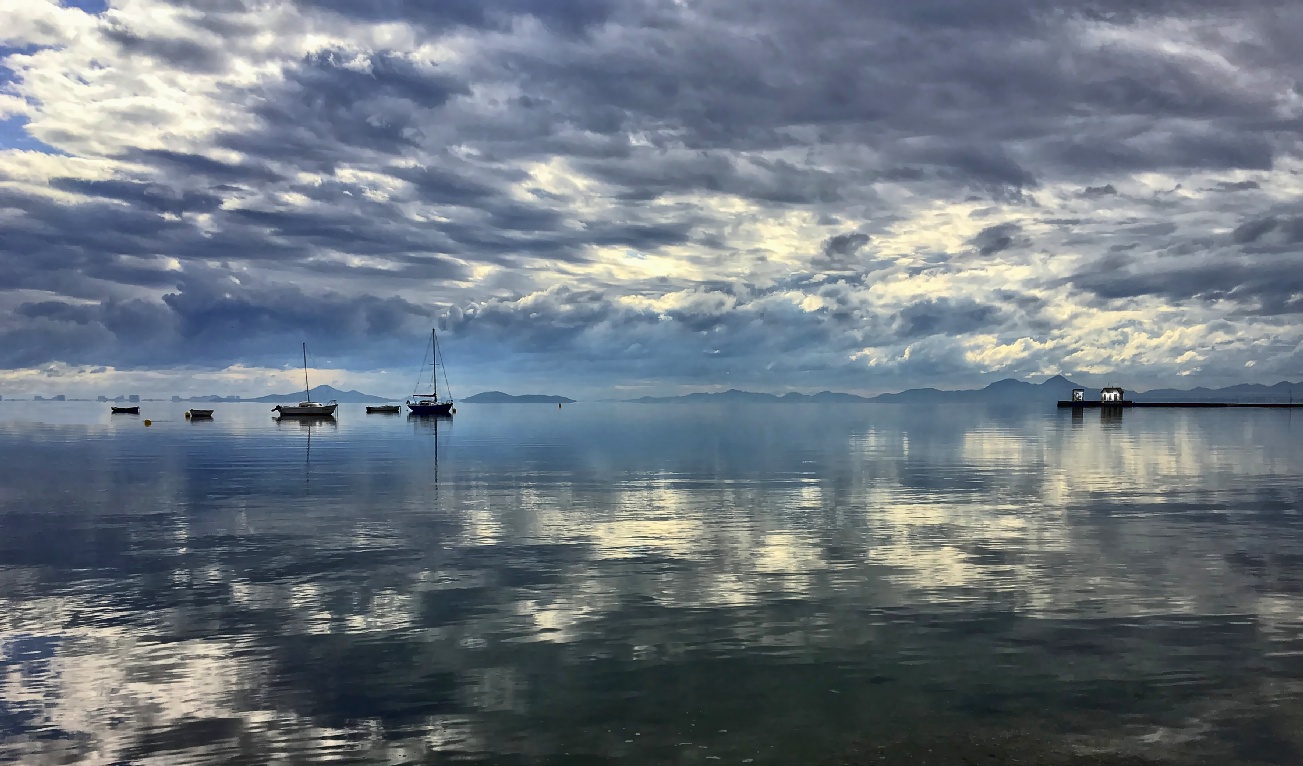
[627,375,1303,404]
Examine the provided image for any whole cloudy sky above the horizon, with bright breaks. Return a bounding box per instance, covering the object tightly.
[0,0,1303,397]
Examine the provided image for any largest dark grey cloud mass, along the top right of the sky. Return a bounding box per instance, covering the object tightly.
[482,3,1285,177]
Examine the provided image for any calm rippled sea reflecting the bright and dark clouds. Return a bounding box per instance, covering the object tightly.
[0,401,1303,765]
